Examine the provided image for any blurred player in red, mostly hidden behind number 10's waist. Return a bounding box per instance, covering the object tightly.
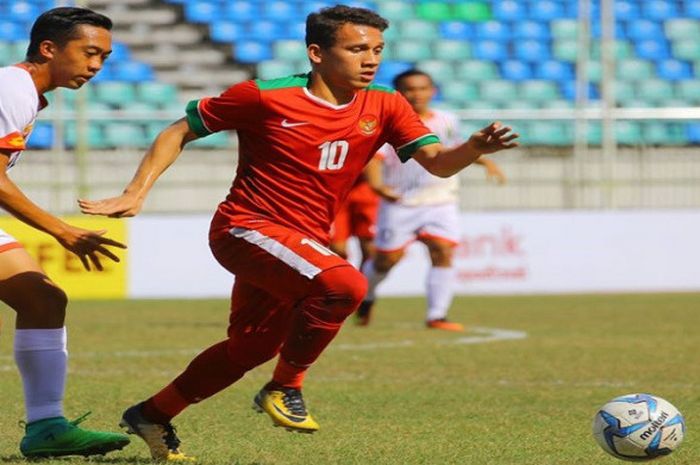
[330,169,379,267]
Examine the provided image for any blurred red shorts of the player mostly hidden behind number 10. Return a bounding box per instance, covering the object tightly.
[331,182,379,242]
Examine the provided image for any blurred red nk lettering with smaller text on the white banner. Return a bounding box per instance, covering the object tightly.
[455,225,528,284]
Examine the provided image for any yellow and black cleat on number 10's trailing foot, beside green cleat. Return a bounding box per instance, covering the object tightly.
[119,404,194,462]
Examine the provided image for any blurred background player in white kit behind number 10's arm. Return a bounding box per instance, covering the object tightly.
[357,70,505,331]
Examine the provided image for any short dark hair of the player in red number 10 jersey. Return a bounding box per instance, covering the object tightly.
[306,5,389,49]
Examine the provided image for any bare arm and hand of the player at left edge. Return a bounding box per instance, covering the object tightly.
[0,151,126,270]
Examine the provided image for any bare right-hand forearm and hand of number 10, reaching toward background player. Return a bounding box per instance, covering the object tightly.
[413,122,518,178]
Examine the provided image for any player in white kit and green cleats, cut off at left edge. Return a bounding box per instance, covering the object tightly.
[0,8,129,457]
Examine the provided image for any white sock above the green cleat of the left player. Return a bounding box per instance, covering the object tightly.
[15,327,68,423]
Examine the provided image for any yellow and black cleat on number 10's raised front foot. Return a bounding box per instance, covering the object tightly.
[253,387,319,433]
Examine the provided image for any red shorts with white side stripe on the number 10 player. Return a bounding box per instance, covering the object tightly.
[210,222,352,335]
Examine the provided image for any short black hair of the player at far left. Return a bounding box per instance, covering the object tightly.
[27,7,112,61]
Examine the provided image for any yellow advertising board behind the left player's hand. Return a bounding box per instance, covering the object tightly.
[0,217,128,299]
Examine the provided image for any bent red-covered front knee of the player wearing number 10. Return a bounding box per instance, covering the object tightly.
[312,265,367,319]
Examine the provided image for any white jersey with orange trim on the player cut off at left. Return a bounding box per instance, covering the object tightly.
[0,66,43,169]
